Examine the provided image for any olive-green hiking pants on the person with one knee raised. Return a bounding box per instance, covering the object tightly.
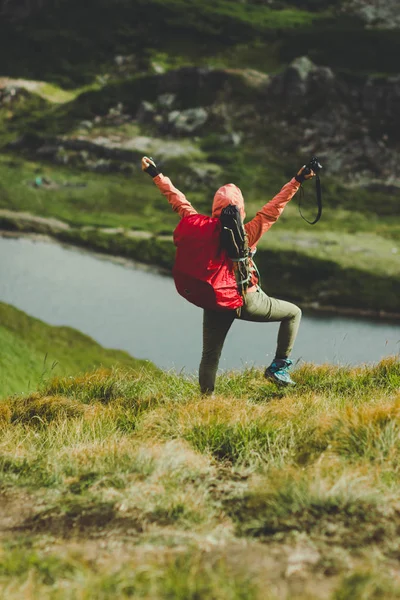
[199,288,301,394]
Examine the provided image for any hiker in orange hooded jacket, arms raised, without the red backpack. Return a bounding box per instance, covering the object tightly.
[142,156,315,394]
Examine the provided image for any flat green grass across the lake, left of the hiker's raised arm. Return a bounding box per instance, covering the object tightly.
[0,152,177,232]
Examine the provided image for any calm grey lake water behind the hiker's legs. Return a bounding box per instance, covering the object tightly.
[0,237,400,372]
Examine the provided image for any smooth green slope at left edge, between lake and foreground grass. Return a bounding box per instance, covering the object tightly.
[0,302,156,397]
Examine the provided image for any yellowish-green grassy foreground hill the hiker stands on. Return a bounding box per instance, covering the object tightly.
[0,359,400,600]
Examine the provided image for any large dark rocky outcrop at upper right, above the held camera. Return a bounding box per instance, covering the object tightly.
[260,57,400,186]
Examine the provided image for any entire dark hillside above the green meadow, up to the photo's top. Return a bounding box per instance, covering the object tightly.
[0,0,400,192]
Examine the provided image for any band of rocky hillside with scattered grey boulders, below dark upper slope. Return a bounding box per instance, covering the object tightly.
[5,56,400,200]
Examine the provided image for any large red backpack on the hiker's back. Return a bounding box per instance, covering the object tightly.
[172,214,243,310]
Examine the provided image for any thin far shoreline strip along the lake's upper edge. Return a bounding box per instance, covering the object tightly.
[0,229,400,324]
